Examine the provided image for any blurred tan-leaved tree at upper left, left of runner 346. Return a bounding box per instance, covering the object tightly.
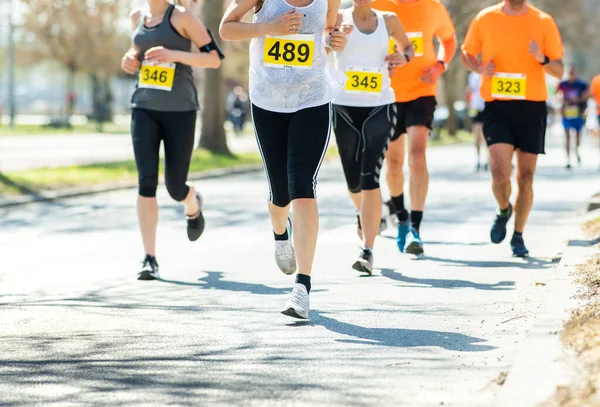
[24,0,129,122]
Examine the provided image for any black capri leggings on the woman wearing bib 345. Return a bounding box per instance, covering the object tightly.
[333,104,397,193]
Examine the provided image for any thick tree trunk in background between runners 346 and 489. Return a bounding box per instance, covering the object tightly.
[199,0,230,154]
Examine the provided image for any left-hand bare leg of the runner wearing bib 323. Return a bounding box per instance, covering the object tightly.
[489,143,515,209]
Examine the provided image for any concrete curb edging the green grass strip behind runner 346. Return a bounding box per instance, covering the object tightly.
[0,164,263,208]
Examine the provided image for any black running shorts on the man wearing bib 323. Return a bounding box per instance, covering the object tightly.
[483,100,548,154]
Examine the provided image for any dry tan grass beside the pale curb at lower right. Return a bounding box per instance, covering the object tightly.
[549,218,600,407]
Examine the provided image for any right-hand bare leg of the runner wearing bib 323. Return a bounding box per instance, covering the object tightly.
[515,151,538,233]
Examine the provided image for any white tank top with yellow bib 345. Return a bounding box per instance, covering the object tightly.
[333,8,396,107]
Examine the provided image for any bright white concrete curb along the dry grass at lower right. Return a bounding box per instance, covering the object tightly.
[495,210,600,407]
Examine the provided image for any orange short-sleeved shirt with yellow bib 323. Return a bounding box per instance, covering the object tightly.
[462,3,564,102]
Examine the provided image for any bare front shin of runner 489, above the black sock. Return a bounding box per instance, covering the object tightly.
[290,199,319,276]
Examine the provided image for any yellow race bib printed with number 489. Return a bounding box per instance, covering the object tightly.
[264,34,315,69]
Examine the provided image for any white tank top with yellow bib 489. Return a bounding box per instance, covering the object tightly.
[249,0,343,113]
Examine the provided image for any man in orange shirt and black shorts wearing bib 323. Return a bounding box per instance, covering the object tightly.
[463,0,564,257]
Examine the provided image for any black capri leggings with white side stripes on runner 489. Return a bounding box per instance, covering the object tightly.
[252,104,331,208]
